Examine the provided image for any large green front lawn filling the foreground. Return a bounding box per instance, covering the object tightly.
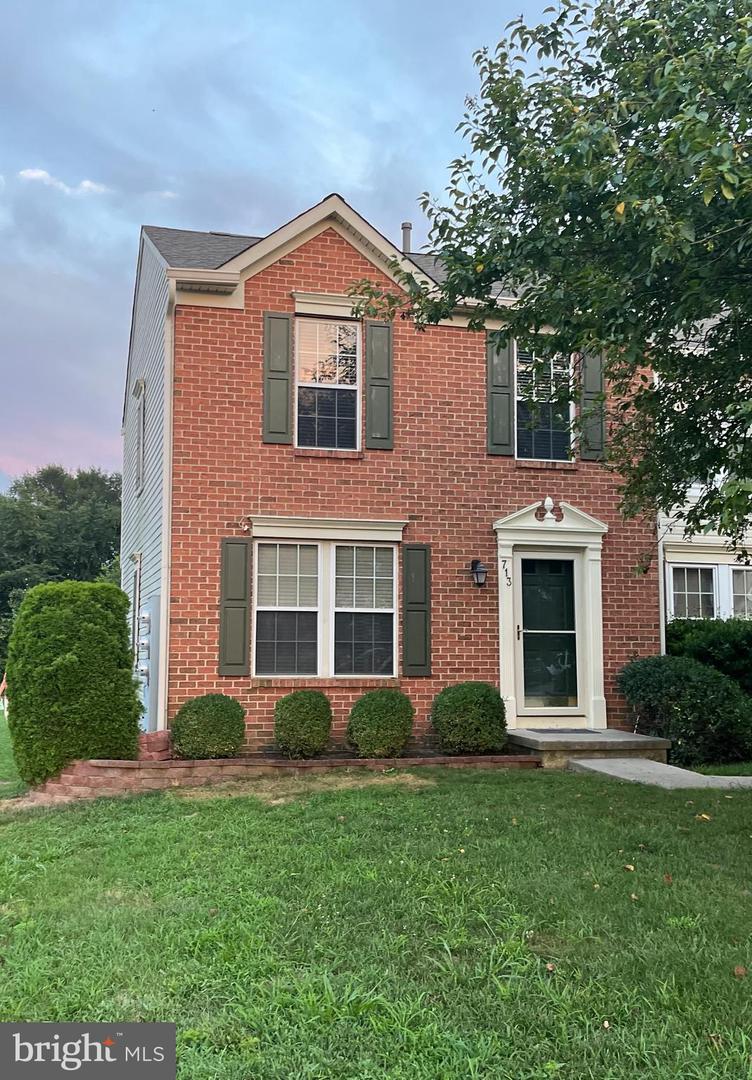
[0,721,752,1080]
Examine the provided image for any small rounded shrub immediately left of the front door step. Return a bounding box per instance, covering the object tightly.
[431,683,507,754]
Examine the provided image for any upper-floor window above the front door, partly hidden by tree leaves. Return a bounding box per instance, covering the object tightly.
[515,350,573,461]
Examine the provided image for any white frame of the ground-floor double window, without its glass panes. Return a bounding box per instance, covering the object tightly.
[251,537,400,681]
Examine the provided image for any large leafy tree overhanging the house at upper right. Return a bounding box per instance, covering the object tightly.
[357,0,752,546]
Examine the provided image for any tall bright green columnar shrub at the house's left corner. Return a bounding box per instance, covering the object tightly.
[8,581,142,784]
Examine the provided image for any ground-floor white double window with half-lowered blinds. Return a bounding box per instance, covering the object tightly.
[254,541,397,676]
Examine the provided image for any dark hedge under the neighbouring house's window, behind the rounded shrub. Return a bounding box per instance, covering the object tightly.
[666,619,752,694]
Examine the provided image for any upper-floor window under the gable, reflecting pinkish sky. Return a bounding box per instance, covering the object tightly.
[295,319,360,450]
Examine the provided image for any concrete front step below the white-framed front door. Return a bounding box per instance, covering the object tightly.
[509,728,671,769]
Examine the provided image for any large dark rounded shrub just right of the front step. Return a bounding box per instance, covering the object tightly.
[617,657,752,766]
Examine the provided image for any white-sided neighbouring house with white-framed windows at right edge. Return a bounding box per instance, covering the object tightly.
[658,490,752,619]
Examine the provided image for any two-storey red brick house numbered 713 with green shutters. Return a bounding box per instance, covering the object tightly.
[122,195,661,746]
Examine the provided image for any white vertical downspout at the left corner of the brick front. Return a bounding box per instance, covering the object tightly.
[157,279,175,731]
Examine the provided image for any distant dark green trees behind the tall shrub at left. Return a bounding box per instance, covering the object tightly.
[0,465,120,671]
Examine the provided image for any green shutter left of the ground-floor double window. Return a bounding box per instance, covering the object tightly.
[219,537,251,675]
